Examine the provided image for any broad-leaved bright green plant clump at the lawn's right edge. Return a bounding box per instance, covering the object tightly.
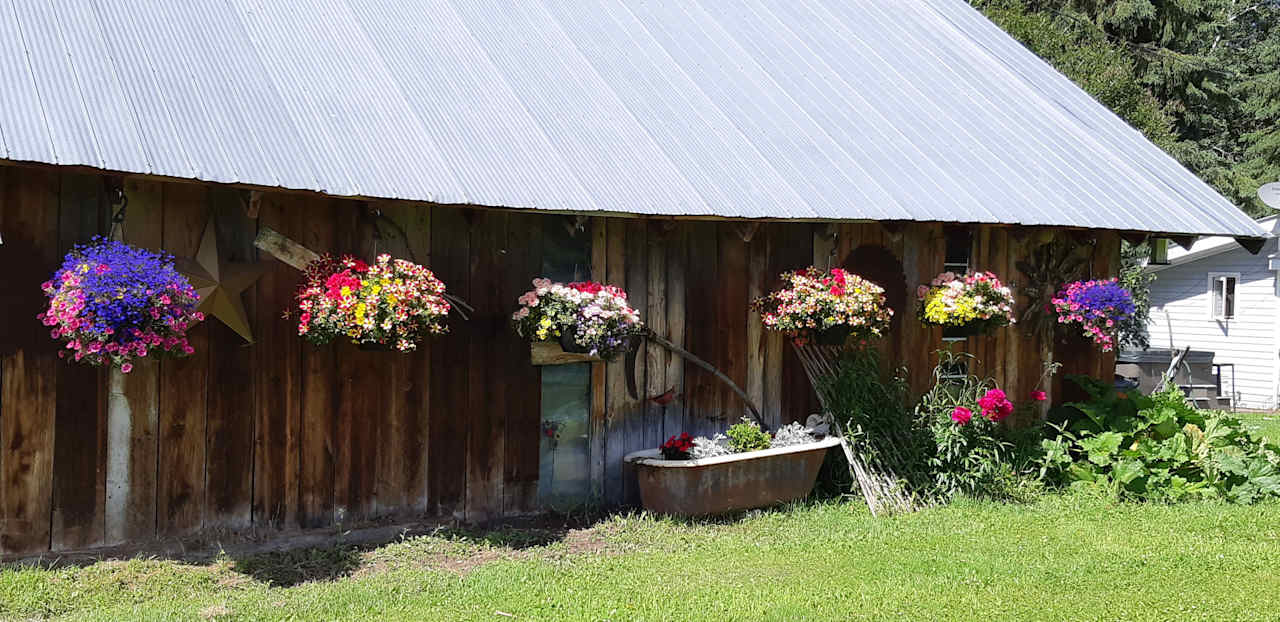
[1041,376,1280,503]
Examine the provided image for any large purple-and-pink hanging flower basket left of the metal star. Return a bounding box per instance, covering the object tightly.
[38,237,205,374]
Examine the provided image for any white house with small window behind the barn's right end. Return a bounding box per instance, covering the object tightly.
[1147,216,1280,410]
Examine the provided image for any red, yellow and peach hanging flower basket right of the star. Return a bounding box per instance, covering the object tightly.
[297,255,449,352]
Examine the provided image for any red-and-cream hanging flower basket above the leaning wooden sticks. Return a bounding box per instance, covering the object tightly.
[751,266,893,346]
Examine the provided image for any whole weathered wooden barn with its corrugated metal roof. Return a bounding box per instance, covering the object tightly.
[0,0,1260,557]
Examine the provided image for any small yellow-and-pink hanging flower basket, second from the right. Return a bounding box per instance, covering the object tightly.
[915,271,1015,337]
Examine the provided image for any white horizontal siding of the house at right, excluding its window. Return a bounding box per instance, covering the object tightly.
[1147,241,1277,408]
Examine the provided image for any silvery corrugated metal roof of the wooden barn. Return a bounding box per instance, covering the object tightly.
[0,0,1263,235]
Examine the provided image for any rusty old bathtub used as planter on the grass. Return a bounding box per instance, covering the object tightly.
[623,436,840,516]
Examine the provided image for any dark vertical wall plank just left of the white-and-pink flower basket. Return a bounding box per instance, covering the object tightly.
[466,211,509,522]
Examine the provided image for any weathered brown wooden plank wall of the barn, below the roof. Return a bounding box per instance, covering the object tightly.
[0,166,1119,555]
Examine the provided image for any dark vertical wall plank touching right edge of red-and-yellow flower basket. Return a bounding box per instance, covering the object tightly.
[429,207,472,517]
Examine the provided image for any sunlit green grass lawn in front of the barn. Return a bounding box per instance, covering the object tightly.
[0,495,1280,621]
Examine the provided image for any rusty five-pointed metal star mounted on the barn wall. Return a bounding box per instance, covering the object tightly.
[177,214,270,343]
